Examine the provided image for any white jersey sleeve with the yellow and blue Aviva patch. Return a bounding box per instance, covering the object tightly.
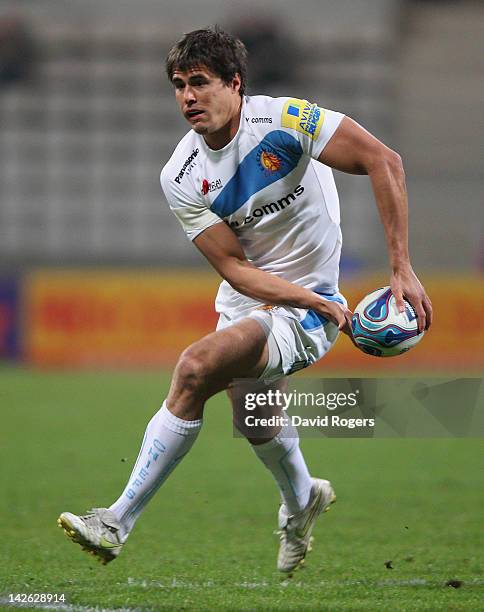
[281,98,344,159]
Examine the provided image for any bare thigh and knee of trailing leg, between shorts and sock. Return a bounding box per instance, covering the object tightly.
[227,377,288,443]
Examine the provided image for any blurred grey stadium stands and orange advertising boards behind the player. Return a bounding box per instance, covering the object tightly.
[0,0,484,373]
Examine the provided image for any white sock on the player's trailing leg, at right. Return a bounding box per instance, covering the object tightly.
[251,425,313,515]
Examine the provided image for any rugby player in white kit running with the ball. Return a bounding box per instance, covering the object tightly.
[58,28,432,573]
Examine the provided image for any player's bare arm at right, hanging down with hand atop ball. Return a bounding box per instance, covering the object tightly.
[318,117,432,331]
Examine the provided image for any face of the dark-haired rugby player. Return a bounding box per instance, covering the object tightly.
[172,66,240,135]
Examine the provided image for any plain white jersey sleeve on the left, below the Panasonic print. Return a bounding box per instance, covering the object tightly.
[160,171,222,240]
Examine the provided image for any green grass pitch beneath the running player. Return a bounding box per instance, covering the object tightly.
[0,369,484,611]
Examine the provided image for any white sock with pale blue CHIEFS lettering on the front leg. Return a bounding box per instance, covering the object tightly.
[109,402,202,538]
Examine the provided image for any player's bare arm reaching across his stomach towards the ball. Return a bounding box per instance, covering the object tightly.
[193,223,351,336]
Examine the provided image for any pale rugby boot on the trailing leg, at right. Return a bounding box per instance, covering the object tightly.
[277,478,336,573]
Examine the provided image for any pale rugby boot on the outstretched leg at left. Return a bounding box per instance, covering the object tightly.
[57,508,124,565]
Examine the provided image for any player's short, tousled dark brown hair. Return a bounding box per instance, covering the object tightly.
[166,26,247,96]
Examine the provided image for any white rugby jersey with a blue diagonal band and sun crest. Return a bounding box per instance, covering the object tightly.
[160,96,343,319]
